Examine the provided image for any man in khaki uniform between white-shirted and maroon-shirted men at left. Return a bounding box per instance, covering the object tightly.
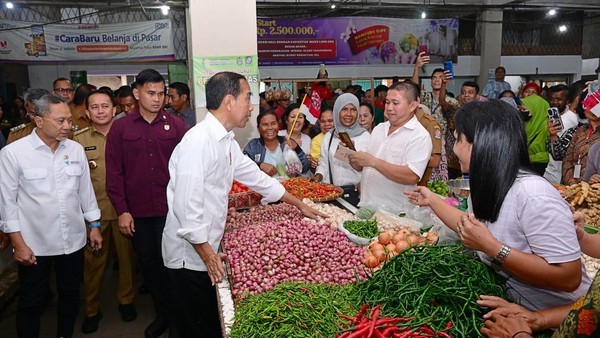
[74,91,137,333]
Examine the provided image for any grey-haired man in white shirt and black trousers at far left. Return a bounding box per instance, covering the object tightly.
[0,94,102,337]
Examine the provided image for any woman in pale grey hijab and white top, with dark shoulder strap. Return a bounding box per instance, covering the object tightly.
[313,93,370,205]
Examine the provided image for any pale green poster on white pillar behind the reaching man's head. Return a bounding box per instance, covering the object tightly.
[193,55,259,108]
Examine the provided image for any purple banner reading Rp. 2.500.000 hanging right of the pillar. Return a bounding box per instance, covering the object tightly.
[257,17,458,66]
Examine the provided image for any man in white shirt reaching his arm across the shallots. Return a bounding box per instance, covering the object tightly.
[162,72,325,338]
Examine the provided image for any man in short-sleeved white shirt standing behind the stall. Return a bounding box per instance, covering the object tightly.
[350,82,432,211]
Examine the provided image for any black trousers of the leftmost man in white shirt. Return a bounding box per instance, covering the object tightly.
[16,248,83,338]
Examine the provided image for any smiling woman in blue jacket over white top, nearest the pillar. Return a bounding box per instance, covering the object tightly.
[244,111,308,176]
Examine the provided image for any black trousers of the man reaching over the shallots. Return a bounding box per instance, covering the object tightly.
[168,269,223,338]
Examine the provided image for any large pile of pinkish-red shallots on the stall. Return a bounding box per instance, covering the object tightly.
[223,204,365,300]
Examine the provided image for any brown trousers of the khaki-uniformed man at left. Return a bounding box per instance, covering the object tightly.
[83,220,135,317]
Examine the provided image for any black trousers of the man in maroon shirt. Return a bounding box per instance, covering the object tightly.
[131,216,175,327]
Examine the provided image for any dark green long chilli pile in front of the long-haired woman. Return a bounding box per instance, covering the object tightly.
[356,246,506,337]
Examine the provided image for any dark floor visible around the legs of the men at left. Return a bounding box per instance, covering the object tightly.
[0,263,168,338]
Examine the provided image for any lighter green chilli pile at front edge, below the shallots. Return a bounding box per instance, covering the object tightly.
[230,283,359,338]
